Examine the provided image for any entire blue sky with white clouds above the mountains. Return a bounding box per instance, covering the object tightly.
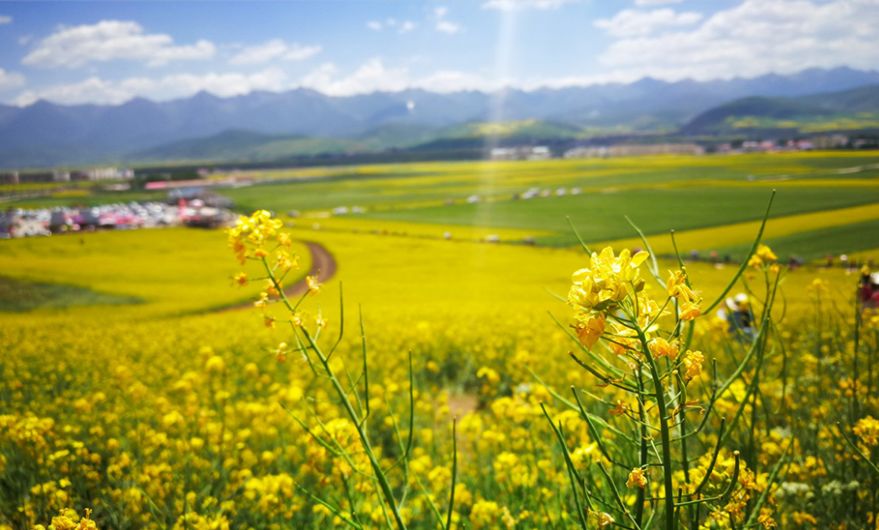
[0,0,879,106]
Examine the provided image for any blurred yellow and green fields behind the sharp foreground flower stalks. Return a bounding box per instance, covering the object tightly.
[0,153,879,529]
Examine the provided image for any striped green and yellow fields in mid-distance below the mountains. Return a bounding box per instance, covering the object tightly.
[4,151,879,259]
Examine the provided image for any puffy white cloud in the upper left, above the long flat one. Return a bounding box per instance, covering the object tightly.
[22,20,216,68]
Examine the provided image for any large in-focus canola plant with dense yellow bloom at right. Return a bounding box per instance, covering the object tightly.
[547,245,786,529]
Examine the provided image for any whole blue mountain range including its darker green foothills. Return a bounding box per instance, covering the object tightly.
[0,68,879,168]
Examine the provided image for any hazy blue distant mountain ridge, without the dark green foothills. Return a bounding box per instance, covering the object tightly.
[0,68,879,168]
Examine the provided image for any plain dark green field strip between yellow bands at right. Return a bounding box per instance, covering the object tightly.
[370,186,879,245]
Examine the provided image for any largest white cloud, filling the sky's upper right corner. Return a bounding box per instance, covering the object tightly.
[599,0,879,80]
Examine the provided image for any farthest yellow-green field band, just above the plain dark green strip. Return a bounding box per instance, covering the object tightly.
[223,155,877,216]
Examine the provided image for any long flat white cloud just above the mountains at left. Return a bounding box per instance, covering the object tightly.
[14,68,290,105]
